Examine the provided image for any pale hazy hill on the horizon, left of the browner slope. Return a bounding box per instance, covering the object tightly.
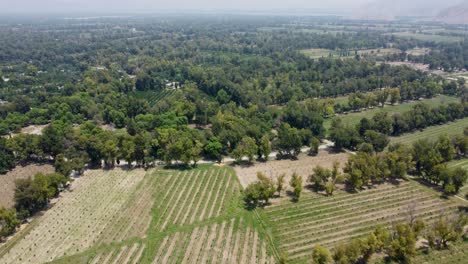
[353,0,461,20]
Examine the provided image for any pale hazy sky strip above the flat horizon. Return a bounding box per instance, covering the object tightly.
[0,0,372,13]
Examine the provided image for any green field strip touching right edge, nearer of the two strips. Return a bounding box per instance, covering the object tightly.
[390,118,468,144]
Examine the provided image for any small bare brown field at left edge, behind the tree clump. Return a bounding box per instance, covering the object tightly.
[0,164,54,208]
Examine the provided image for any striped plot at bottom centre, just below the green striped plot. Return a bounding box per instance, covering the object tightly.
[149,217,274,264]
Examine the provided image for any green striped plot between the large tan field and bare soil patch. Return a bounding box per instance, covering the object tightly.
[151,166,240,231]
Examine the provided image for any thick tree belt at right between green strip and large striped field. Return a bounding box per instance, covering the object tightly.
[340,130,468,194]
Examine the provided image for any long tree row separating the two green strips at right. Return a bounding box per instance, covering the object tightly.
[330,100,468,152]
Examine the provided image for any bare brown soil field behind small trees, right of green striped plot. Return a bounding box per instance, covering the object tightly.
[234,150,349,188]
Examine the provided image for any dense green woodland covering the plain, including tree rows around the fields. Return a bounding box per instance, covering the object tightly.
[0,16,468,256]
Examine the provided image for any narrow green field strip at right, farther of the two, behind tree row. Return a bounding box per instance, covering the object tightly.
[324,95,460,130]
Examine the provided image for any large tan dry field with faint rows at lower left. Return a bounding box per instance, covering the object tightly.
[0,169,146,264]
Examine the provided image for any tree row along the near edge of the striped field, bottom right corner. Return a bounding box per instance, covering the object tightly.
[312,214,468,264]
